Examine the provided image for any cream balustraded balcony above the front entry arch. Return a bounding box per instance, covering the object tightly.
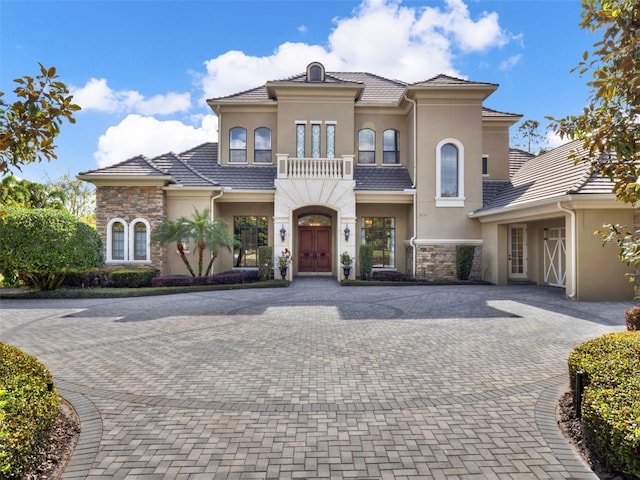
[276,153,354,180]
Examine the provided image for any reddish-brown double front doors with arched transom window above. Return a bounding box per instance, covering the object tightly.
[298,213,332,273]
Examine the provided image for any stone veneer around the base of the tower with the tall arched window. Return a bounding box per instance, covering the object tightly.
[416,245,482,281]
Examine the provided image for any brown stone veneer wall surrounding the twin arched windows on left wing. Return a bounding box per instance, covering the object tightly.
[96,186,166,271]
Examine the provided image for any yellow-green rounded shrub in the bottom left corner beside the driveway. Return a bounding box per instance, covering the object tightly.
[0,343,58,479]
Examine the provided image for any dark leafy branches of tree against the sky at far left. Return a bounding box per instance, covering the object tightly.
[0,63,80,174]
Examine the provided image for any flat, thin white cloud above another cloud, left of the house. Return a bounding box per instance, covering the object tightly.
[70,78,191,115]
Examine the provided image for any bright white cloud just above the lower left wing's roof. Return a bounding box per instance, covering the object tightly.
[94,114,218,168]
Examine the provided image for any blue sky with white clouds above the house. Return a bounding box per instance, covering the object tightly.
[0,0,598,181]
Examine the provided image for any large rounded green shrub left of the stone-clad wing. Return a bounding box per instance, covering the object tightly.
[0,208,103,290]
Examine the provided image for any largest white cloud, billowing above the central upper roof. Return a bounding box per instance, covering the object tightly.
[202,0,512,98]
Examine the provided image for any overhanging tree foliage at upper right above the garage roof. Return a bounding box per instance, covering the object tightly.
[551,0,640,203]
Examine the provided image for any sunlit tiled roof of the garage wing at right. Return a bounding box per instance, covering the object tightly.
[481,141,613,211]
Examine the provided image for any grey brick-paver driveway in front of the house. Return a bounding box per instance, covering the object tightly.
[0,278,631,479]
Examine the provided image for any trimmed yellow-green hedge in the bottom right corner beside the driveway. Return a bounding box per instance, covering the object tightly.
[568,332,640,478]
